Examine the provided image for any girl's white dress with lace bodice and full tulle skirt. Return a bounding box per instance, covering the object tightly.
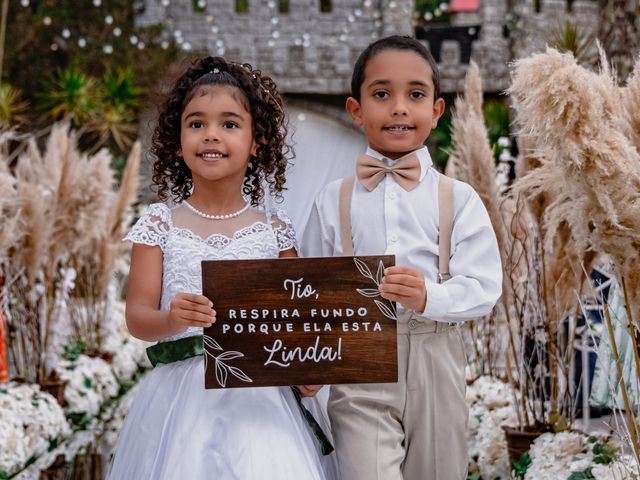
[108,204,337,480]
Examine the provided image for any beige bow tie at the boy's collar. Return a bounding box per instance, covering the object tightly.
[356,152,420,192]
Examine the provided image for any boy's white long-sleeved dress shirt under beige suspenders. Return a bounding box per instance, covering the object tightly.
[301,147,502,322]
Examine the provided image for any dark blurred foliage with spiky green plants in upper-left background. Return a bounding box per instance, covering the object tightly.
[0,0,181,170]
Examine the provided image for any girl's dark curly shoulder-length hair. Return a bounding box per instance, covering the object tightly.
[151,57,292,206]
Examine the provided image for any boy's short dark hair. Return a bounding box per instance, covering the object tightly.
[351,35,440,101]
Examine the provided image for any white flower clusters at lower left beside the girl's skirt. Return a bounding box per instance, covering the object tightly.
[0,326,149,480]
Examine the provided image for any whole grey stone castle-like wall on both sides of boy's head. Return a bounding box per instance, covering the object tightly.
[137,0,598,95]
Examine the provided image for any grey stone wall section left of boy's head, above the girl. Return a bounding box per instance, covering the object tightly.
[137,0,413,94]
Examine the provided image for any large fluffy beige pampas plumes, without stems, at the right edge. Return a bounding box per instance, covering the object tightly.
[509,49,640,322]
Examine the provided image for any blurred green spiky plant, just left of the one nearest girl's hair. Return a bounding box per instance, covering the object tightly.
[38,68,99,127]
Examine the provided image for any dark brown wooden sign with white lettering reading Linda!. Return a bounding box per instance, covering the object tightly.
[202,255,398,388]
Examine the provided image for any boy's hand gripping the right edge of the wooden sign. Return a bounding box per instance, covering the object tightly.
[378,266,427,313]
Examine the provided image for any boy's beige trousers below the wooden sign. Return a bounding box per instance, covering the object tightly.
[329,314,469,480]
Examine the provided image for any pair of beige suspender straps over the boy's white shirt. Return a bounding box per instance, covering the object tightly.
[338,175,453,283]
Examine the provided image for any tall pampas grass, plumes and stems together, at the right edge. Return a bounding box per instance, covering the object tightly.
[509,49,640,465]
